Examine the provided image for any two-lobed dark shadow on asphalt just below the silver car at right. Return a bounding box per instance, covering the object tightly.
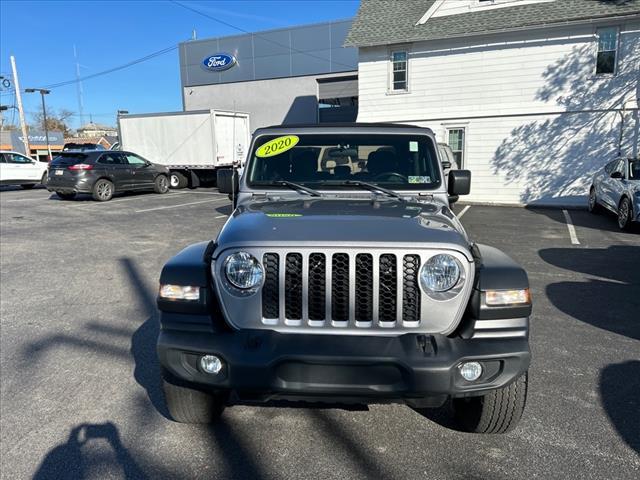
[539,246,640,340]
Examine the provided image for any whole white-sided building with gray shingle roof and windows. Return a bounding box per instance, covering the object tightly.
[346,0,640,205]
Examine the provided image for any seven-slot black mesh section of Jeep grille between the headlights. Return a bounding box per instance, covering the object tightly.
[262,252,420,327]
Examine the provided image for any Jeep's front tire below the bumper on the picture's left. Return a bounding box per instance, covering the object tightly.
[162,378,226,423]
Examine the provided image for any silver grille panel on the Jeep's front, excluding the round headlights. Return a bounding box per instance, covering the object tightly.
[214,246,474,335]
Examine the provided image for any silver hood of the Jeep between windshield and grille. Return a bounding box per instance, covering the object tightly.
[216,198,469,256]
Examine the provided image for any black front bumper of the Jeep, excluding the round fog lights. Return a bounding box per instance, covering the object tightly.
[158,330,530,403]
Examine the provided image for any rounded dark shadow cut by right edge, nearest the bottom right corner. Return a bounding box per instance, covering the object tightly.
[600,360,640,455]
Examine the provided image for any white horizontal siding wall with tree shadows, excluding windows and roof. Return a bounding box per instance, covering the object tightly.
[358,23,640,204]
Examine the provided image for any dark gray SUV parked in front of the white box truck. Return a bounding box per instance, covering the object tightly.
[47,150,169,202]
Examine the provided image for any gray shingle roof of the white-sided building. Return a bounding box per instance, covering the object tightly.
[345,0,640,47]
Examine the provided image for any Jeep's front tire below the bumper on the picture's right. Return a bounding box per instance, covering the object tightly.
[453,373,528,433]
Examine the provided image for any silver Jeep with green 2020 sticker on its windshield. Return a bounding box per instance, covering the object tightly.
[158,123,531,433]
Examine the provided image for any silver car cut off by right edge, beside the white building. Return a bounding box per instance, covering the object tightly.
[589,157,640,229]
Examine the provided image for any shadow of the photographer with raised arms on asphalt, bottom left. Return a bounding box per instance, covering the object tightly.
[33,422,149,480]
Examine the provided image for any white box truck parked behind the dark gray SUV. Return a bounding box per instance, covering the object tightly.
[118,110,251,188]
